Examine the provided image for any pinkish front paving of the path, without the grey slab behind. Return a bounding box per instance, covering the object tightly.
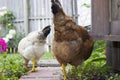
[19,67,62,80]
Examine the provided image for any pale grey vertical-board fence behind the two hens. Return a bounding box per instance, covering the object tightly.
[0,0,77,32]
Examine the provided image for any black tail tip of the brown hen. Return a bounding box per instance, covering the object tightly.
[51,0,62,15]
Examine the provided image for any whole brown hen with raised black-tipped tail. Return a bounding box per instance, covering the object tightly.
[51,0,93,80]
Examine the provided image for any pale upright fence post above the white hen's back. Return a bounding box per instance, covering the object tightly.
[24,0,29,35]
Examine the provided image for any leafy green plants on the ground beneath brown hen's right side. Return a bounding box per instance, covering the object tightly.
[68,54,108,80]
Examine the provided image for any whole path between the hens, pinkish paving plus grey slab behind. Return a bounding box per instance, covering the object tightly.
[19,60,62,80]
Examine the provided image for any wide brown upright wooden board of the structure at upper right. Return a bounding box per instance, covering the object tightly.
[92,0,110,35]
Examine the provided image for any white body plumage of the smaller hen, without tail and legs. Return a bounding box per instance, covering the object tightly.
[18,31,46,60]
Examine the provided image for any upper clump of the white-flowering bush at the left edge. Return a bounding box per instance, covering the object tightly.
[0,9,15,37]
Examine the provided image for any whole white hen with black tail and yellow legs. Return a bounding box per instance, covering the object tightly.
[18,26,51,72]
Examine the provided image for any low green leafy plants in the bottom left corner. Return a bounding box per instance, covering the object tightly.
[0,54,26,80]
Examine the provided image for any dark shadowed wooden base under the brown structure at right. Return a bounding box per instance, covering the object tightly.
[107,41,120,71]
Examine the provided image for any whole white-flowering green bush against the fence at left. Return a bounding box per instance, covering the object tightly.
[0,9,24,48]
